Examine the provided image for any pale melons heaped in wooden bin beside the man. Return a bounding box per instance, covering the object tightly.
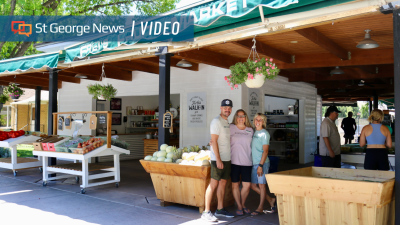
[144,144,211,166]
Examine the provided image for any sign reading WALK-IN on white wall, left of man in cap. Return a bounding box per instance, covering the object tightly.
[187,92,207,127]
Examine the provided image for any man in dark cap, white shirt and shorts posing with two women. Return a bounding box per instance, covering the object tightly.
[201,99,235,222]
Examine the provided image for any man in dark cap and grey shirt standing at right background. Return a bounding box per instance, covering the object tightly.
[319,106,342,168]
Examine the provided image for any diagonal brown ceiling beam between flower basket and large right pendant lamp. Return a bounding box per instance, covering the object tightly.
[296,27,349,60]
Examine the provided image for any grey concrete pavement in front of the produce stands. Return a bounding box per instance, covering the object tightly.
[0,160,310,225]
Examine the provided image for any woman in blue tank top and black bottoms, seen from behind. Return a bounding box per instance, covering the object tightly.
[360,109,392,171]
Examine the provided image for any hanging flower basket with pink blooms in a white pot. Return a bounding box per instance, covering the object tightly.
[225,58,280,90]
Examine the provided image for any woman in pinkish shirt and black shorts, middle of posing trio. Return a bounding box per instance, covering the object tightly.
[229,109,254,216]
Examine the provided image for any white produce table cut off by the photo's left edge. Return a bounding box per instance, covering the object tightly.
[0,136,42,176]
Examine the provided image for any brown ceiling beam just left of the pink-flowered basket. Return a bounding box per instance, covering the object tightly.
[174,49,242,69]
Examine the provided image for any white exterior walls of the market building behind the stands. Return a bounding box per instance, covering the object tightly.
[59,64,317,163]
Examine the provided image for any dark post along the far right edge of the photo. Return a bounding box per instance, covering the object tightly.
[393,5,400,225]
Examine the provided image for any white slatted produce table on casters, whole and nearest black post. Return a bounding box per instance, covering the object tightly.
[33,145,130,194]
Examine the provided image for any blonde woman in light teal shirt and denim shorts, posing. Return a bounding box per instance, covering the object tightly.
[251,113,276,216]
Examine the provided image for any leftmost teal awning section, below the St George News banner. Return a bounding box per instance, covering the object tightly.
[0,52,59,74]
